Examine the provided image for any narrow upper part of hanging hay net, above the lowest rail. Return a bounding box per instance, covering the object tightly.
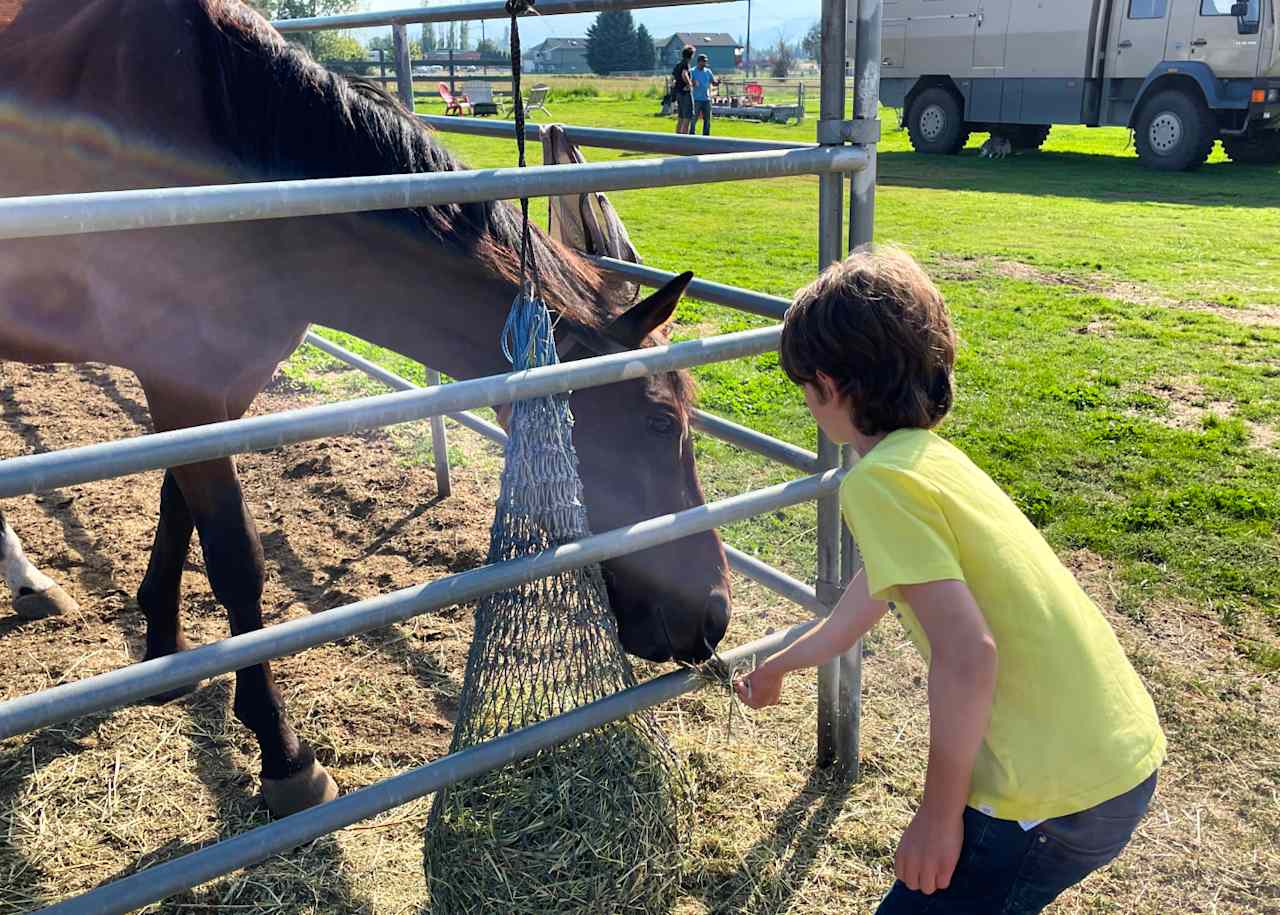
[454,297,645,746]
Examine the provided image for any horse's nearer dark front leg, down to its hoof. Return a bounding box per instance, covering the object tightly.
[143,384,338,816]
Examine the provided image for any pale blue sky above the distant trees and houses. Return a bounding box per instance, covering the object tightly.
[361,0,819,47]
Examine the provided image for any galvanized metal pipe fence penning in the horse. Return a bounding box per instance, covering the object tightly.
[0,0,882,912]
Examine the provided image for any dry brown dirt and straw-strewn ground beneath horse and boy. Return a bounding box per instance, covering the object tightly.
[0,363,1280,915]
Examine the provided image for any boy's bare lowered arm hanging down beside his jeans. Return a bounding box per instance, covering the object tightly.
[896,581,997,893]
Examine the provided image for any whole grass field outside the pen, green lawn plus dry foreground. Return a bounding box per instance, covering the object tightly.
[264,93,1280,915]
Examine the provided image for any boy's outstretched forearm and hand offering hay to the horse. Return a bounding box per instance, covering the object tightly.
[733,571,888,709]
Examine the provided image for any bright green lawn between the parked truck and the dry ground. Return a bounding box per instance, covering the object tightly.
[302,93,1280,671]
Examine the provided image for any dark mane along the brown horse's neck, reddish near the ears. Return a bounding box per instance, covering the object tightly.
[198,0,620,328]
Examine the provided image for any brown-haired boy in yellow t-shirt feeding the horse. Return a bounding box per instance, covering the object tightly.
[735,250,1165,915]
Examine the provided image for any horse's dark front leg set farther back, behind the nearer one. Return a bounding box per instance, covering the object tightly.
[138,471,200,703]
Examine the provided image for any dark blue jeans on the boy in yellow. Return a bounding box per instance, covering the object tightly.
[876,773,1156,915]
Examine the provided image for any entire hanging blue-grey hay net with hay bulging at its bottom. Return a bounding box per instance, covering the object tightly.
[425,297,689,915]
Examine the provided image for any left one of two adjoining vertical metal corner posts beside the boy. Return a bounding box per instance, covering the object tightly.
[815,0,858,777]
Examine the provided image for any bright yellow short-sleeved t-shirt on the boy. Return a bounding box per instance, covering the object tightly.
[840,429,1165,820]
